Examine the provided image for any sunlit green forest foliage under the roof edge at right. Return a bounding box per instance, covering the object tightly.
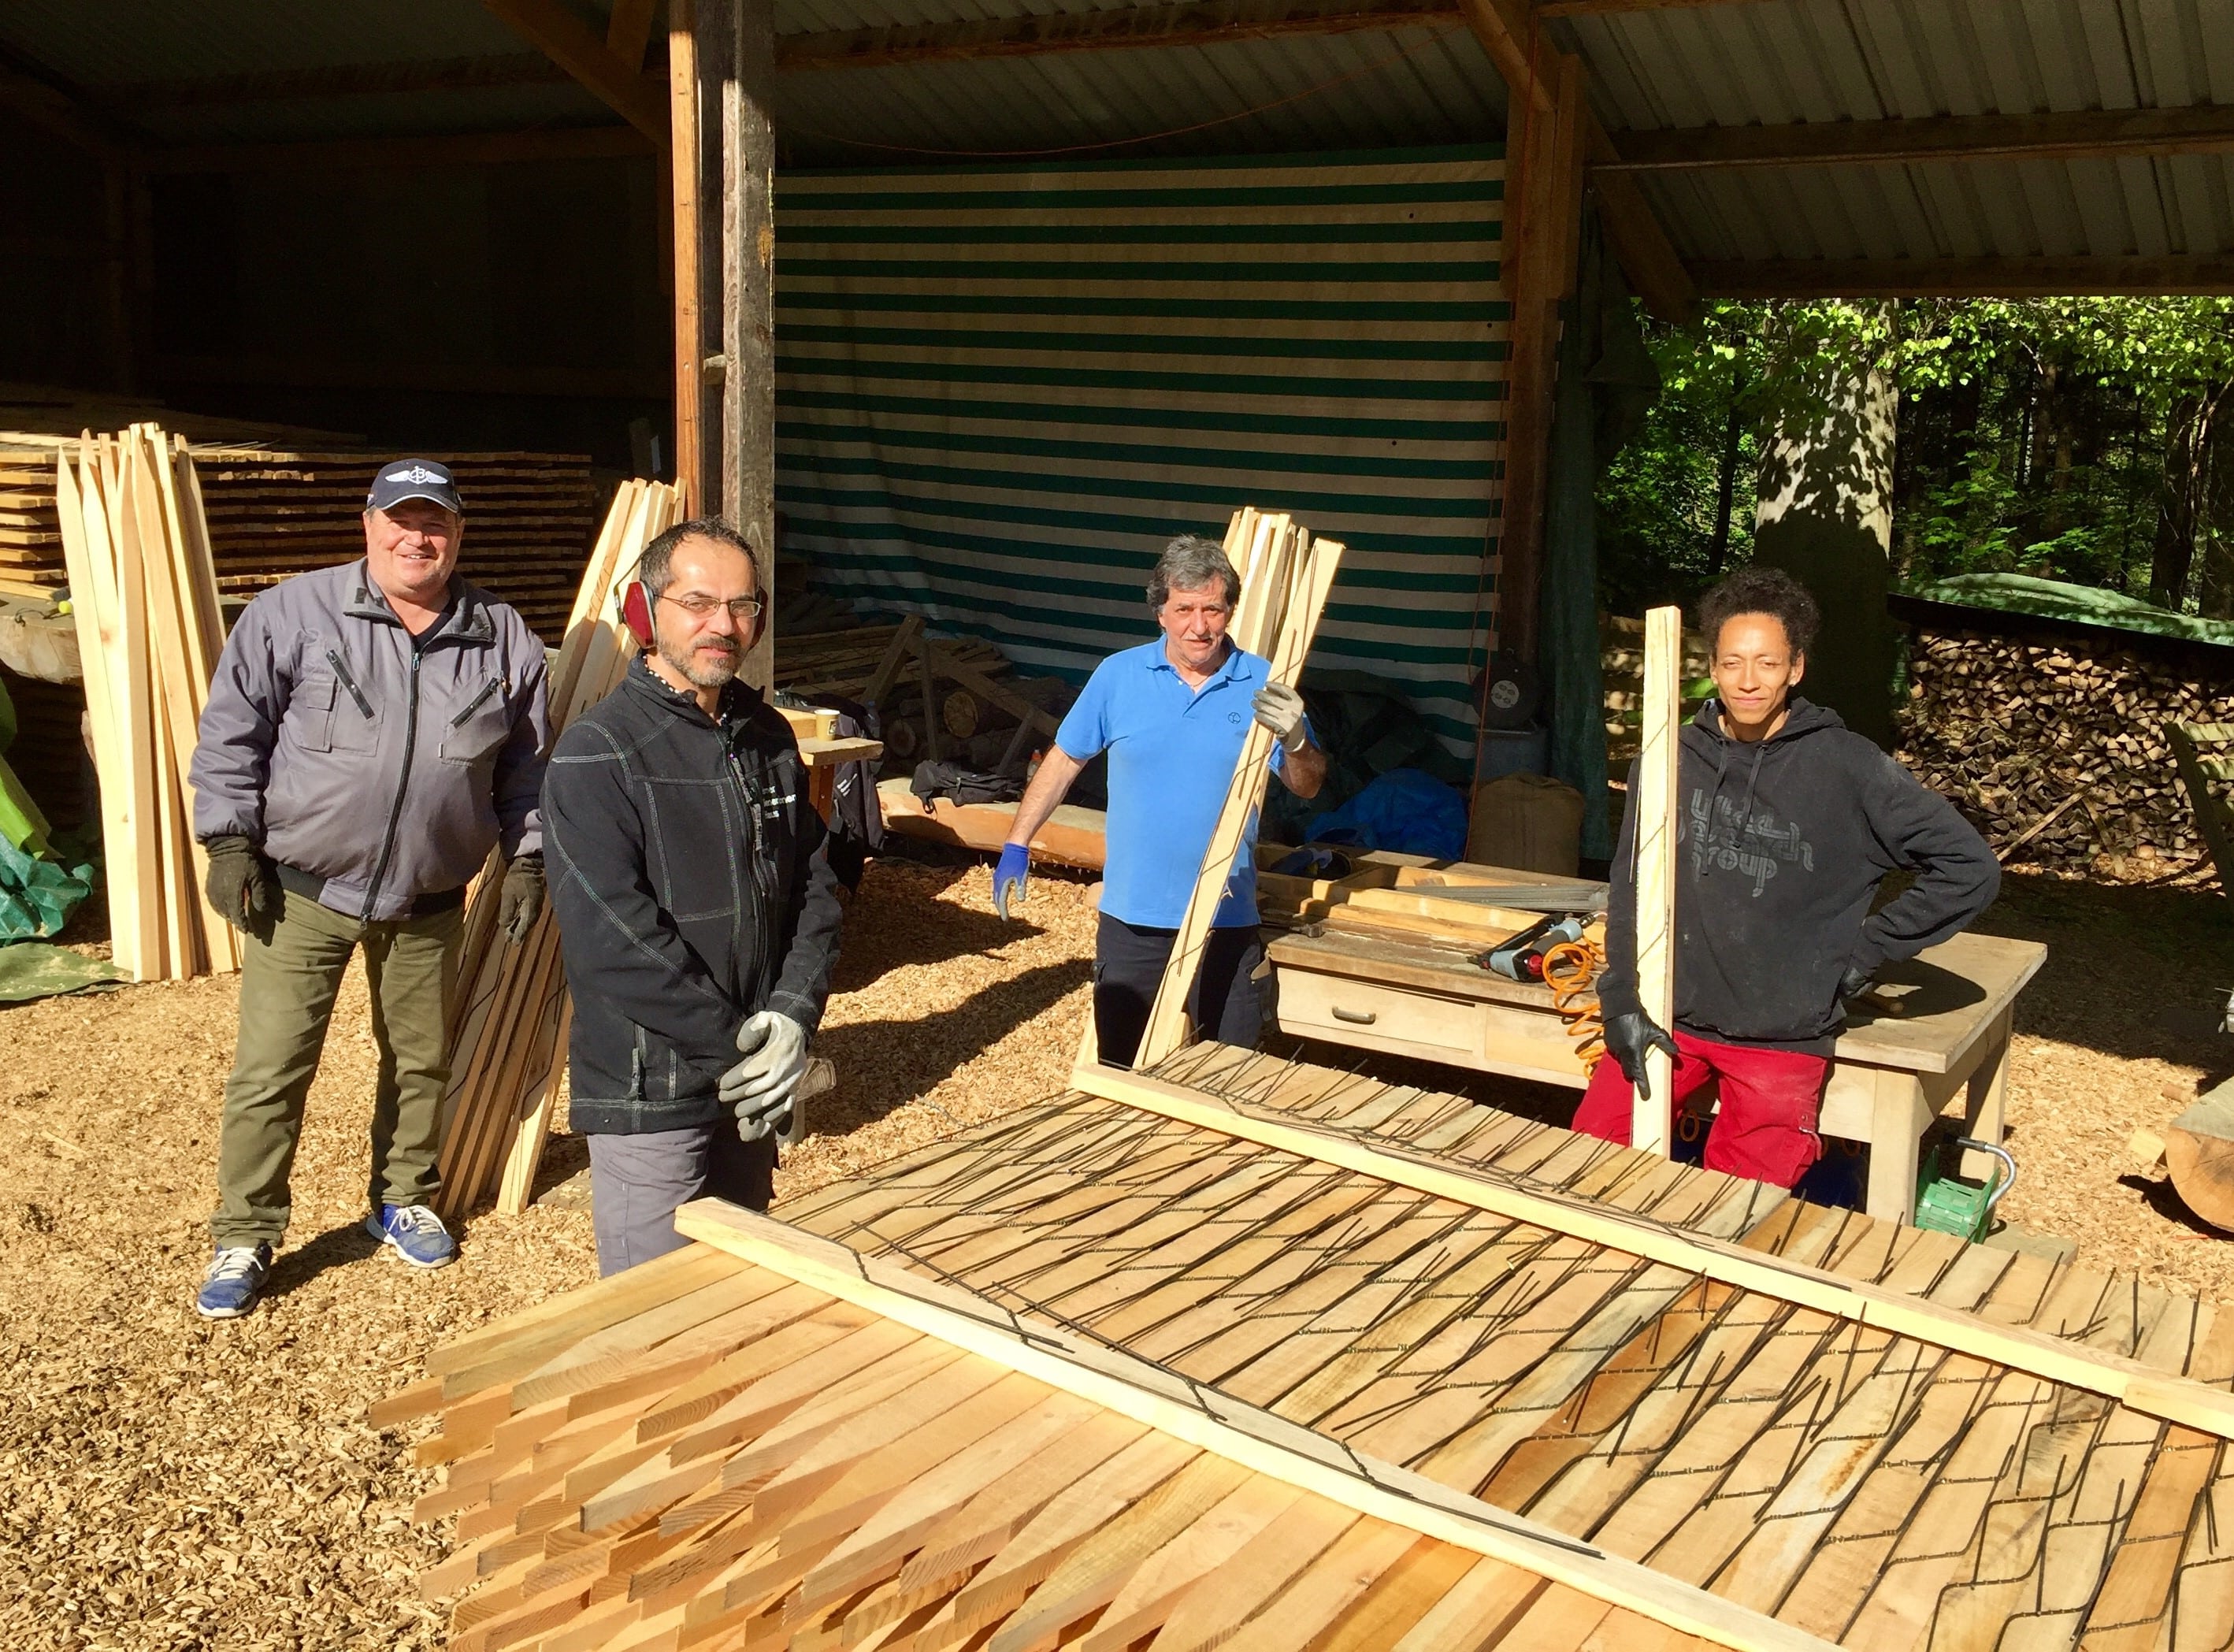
[1598,297,2234,617]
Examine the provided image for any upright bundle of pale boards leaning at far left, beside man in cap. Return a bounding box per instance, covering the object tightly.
[47,425,241,982]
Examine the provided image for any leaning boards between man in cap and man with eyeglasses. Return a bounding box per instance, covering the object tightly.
[440,481,681,1219]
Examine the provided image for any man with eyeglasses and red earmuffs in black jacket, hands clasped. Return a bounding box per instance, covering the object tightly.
[543,516,840,1274]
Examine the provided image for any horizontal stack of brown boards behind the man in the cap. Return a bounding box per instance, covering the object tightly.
[0,432,594,641]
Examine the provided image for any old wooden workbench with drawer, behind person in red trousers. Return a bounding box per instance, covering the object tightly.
[1269,930,2049,1223]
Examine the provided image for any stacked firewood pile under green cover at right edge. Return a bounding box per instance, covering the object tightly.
[1899,630,2234,872]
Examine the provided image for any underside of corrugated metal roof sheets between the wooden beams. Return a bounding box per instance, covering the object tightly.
[0,0,2234,278]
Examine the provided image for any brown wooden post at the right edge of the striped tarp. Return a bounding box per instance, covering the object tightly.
[1497,47,1586,659]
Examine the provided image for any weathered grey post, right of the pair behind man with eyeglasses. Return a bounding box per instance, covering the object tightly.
[723,0,777,689]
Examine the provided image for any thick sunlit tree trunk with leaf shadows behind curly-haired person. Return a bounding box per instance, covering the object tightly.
[1751,324,1899,749]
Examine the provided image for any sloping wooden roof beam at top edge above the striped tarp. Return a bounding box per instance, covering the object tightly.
[775,0,1459,74]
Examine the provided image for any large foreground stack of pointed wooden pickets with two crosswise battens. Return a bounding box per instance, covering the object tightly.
[384,1046,2234,1652]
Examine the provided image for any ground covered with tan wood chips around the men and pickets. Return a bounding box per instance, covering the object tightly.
[0,863,2234,1652]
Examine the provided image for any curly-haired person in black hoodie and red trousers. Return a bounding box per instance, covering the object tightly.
[1575,568,2002,1187]
